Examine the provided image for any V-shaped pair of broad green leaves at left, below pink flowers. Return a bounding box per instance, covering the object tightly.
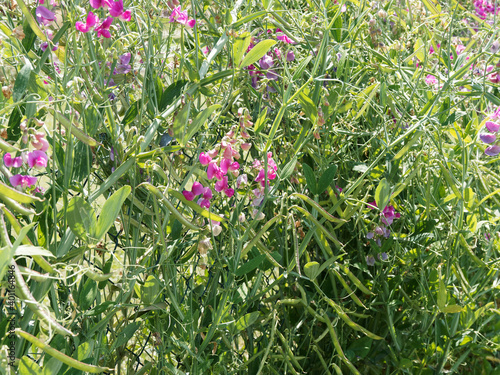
[67,186,132,243]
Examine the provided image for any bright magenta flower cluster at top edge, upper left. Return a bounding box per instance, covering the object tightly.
[75,0,131,38]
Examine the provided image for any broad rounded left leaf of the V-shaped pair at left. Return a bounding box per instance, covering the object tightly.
[66,196,97,243]
